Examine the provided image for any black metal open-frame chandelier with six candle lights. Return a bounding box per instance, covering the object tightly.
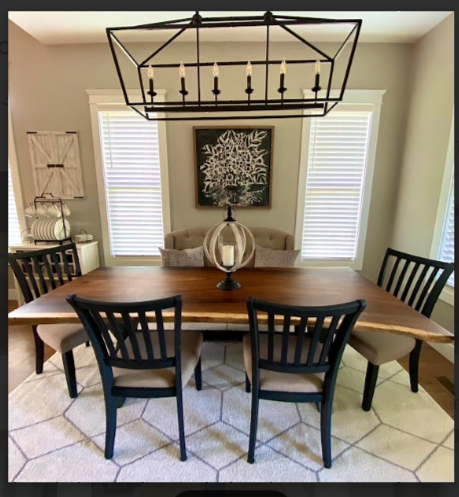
[106,12,362,121]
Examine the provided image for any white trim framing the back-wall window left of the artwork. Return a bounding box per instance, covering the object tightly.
[86,88,171,266]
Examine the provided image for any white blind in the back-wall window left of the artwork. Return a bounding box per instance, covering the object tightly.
[99,110,164,257]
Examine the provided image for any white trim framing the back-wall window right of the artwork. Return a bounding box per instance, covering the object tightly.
[295,90,386,270]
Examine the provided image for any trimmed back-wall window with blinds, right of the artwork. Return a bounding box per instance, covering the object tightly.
[296,90,382,269]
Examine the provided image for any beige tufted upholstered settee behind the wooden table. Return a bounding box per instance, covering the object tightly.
[164,228,295,331]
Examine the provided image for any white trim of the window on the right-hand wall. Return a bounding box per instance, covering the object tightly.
[430,109,454,306]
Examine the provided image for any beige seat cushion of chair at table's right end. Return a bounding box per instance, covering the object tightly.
[348,331,416,366]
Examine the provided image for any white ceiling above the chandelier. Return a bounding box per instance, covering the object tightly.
[9,11,451,45]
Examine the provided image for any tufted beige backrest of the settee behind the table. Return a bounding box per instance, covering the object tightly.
[164,228,295,267]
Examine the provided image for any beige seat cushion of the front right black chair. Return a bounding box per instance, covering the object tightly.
[242,335,325,393]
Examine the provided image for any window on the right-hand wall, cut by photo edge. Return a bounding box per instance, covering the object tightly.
[430,112,454,296]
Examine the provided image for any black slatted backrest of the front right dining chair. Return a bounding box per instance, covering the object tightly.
[247,297,366,380]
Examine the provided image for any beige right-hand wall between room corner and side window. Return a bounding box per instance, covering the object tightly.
[392,14,454,331]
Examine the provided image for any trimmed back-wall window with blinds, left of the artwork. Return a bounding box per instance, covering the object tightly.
[88,90,169,265]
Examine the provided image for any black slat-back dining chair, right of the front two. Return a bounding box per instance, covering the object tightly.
[243,297,366,468]
